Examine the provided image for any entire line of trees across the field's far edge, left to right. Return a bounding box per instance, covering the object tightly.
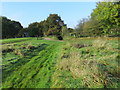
[0,2,120,38]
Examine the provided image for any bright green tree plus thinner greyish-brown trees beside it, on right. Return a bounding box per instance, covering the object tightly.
[76,2,120,37]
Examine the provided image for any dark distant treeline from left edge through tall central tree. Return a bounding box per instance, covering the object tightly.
[1,14,73,38]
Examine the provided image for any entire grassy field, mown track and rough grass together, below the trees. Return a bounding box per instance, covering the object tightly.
[1,38,120,88]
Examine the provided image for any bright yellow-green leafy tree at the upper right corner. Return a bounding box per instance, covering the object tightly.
[91,2,120,36]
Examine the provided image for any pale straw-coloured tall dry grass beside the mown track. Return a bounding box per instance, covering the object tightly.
[53,39,118,88]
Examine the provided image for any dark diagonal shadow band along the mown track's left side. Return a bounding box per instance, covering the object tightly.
[2,44,48,82]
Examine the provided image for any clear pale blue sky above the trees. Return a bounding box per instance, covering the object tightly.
[1,2,96,28]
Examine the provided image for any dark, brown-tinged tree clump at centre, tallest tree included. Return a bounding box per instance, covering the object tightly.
[23,14,64,36]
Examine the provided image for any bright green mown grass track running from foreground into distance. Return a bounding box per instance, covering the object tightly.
[3,40,62,88]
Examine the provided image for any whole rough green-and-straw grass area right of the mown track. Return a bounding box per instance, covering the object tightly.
[52,39,120,88]
